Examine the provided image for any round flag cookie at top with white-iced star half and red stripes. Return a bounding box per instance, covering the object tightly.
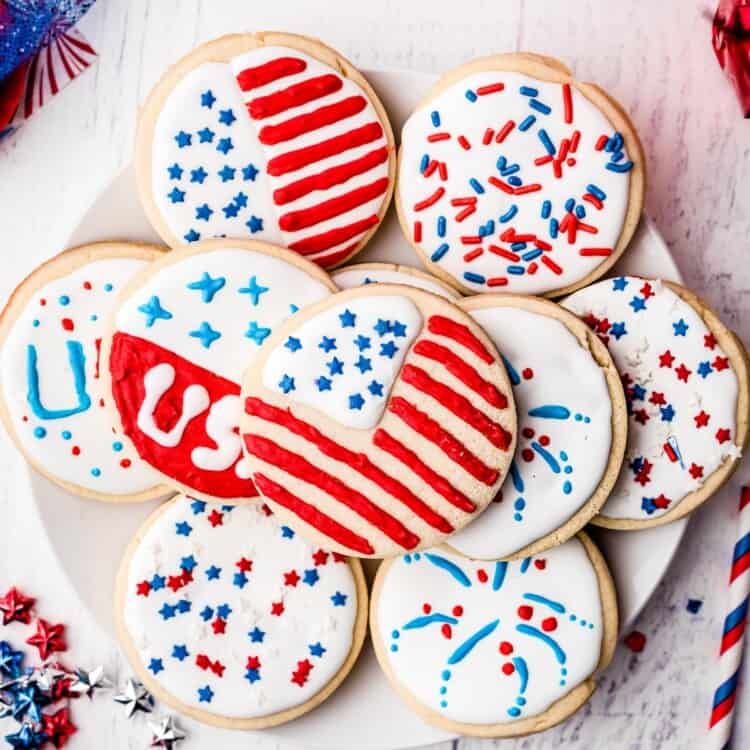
[136,32,395,268]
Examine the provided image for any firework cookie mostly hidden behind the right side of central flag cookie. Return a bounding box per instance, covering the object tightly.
[446,294,628,559]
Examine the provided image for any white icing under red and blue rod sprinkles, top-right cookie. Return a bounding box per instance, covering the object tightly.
[398,71,633,294]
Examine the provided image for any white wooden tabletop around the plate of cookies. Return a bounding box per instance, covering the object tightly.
[0,0,750,750]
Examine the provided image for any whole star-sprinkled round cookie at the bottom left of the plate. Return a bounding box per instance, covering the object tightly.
[115,495,367,729]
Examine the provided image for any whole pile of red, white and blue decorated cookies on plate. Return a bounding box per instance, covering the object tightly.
[0,33,748,737]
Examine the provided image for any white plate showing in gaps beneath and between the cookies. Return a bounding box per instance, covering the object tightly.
[23,71,685,750]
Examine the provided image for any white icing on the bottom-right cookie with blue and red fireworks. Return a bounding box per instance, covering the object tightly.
[374,539,604,724]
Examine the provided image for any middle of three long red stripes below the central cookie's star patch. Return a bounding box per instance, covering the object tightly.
[243,435,420,549]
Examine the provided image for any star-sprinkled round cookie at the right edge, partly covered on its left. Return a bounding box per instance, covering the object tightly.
[564,276,749,529]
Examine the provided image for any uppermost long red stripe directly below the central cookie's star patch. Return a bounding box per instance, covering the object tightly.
[245,398,454,534]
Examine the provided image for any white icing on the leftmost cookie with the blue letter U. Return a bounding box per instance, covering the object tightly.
[0,258,159,495]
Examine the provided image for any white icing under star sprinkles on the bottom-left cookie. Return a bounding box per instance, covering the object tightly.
[124,497,358,718]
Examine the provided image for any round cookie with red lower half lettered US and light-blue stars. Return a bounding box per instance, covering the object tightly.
[102,240,336,501]
